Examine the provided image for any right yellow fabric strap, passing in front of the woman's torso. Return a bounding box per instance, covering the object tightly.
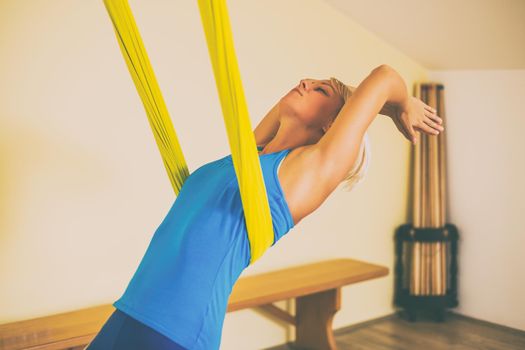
[194,0,274,264]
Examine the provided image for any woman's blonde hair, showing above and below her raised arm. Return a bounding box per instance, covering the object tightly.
[330,77,372,191]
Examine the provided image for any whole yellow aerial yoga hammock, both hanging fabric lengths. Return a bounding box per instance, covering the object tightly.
[104,0,274,264]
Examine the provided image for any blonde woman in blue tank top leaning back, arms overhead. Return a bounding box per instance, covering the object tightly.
[87,65,443,350]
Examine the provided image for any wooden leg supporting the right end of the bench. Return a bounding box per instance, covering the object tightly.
[294,288,341,350]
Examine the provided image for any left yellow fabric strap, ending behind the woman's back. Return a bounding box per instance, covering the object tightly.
[104,0,189,195]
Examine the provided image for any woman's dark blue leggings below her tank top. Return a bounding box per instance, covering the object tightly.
[86,309,187,350]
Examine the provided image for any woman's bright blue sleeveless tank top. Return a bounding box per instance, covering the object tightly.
[113,147,294,350]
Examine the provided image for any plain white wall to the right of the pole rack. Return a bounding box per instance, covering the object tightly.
[429,70,525,330]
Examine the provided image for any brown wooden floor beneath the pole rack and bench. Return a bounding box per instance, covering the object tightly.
[266,312,525,350]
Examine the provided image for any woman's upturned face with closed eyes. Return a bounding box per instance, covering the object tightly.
[279,79,344,129]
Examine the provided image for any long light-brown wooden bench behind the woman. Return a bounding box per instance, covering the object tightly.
[0,259,388,350]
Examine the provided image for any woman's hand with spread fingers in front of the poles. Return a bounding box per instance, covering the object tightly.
[392,96,445,145]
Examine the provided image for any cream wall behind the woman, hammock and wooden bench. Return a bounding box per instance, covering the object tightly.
[0,0,426,349]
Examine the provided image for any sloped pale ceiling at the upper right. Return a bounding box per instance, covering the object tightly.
[324,0,525,70]
